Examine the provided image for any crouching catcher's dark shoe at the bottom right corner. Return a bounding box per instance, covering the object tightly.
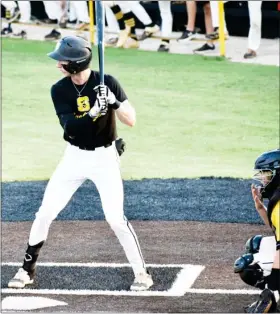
[244,289,277,313]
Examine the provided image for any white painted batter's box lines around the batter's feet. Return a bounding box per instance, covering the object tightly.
[1,262,205,297]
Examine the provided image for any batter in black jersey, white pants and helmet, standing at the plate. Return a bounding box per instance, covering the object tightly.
[8,36,153,291]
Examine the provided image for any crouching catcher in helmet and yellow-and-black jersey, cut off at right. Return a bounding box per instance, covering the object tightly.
[234,149,280,313]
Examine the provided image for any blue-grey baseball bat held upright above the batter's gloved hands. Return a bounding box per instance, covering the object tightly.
[95,0,105,85]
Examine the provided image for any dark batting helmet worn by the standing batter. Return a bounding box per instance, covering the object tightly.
[48,36,92,74]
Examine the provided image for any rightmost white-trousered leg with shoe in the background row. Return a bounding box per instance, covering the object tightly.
[244,1,262,59]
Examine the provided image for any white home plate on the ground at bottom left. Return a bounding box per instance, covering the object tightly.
[2,296,67,311]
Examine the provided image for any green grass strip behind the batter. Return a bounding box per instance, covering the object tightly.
[2,39,279,181]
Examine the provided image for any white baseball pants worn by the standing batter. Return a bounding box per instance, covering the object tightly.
[29,143,145,274]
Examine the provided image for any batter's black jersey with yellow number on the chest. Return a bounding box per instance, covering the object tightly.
[51,71,127,150]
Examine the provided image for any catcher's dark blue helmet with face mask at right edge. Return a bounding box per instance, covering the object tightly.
[253,149,280,198]
